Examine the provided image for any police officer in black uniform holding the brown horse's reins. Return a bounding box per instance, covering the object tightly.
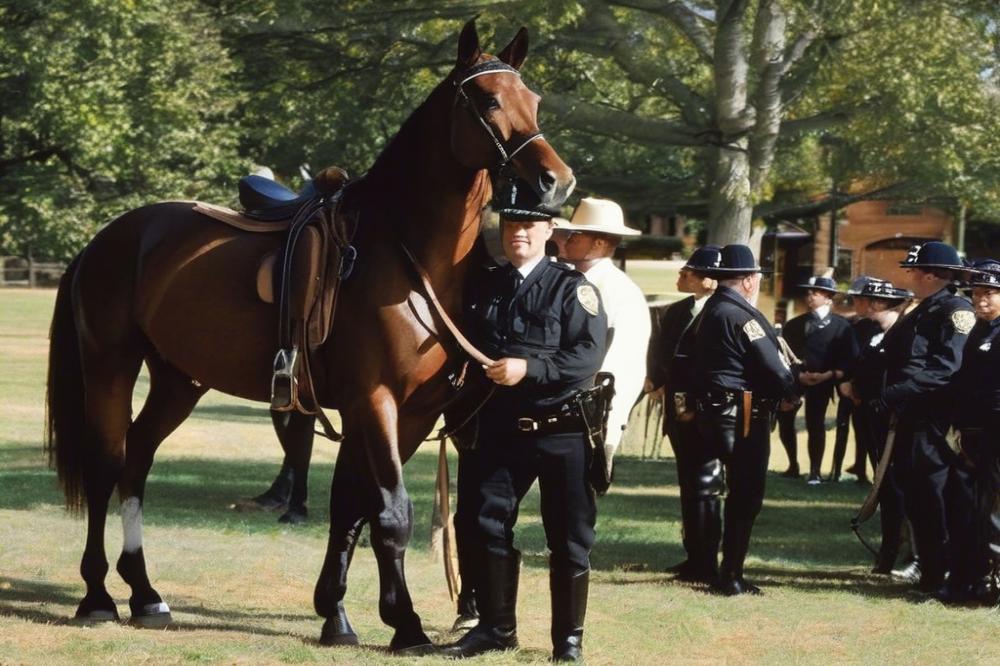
[445,185,608,661]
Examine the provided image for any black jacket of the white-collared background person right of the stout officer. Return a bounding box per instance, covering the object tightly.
[781,312,858,375]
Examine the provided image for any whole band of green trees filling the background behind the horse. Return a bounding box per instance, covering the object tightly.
[0,0,1000,254]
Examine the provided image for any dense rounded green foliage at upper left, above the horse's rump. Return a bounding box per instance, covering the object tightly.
[0,0,246,259]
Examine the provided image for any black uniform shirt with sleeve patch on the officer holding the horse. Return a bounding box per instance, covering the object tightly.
[468,258,608,419]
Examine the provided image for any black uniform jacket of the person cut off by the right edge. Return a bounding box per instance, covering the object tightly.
[950,318,1000,428]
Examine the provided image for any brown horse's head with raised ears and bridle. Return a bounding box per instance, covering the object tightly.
[451,20,576,207]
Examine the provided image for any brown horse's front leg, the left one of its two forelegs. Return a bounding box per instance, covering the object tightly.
[313,438,371,645]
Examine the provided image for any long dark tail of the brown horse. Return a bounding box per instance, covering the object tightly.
[45,255,89,513]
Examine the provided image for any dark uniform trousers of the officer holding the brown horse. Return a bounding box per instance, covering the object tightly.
[456,427,597,575]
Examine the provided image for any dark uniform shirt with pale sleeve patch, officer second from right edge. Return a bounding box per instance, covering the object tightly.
[882,288,975,414]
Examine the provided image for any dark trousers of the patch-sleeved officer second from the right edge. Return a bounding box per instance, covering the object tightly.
[893,413,974,587]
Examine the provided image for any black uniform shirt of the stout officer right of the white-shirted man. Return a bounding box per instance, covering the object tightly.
[693,286,795,399]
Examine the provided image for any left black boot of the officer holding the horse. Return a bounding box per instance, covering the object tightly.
[443,551,521,658]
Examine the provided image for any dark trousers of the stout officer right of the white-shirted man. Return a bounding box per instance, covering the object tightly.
[697,406,771,579]
